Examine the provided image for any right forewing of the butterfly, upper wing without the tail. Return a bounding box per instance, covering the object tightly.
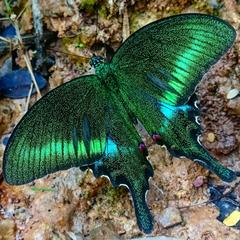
[111,14,236,105]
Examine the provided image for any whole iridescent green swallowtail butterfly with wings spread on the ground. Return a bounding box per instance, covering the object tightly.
[3,14,236,233]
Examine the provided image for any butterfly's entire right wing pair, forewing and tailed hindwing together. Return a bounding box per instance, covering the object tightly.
[111,14,236,181]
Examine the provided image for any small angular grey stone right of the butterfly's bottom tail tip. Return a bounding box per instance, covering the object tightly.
[159,207,182,228]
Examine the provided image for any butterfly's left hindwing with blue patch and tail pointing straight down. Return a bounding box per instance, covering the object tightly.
[93,94,153,233]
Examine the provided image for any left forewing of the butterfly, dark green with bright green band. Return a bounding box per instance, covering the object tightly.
[3,75,106,185]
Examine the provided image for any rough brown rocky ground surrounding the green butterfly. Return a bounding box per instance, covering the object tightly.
[0,0,240,240]
